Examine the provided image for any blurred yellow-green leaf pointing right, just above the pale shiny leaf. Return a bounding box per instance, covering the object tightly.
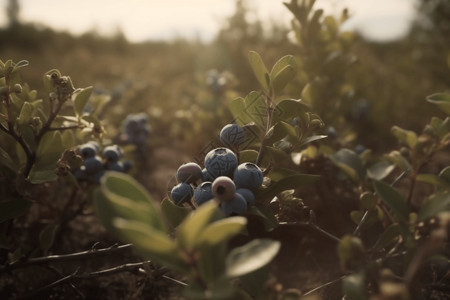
[197,217,247,246]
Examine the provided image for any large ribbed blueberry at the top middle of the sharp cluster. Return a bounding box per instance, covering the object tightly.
[205,148,238,178]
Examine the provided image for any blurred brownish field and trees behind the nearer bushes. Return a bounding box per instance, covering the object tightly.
[0,0,450,157]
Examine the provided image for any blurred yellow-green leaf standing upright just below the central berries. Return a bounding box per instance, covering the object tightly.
[177,201,218,249]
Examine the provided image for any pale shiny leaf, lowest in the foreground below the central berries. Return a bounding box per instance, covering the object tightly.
[225,239,281,277]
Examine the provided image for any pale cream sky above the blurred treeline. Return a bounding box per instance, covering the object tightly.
[0,0,416,42]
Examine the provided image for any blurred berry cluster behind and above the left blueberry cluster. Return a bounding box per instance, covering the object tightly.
[121,113,151,148]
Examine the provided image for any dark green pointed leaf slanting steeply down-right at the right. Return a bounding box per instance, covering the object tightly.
[373,180,409,222]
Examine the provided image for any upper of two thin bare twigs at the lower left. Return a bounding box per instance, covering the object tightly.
[0,244,132,274]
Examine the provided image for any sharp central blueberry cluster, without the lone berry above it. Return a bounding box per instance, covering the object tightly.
[171,148,264,216]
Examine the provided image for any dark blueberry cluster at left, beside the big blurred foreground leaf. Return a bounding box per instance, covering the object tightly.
[73,141,132,183]
